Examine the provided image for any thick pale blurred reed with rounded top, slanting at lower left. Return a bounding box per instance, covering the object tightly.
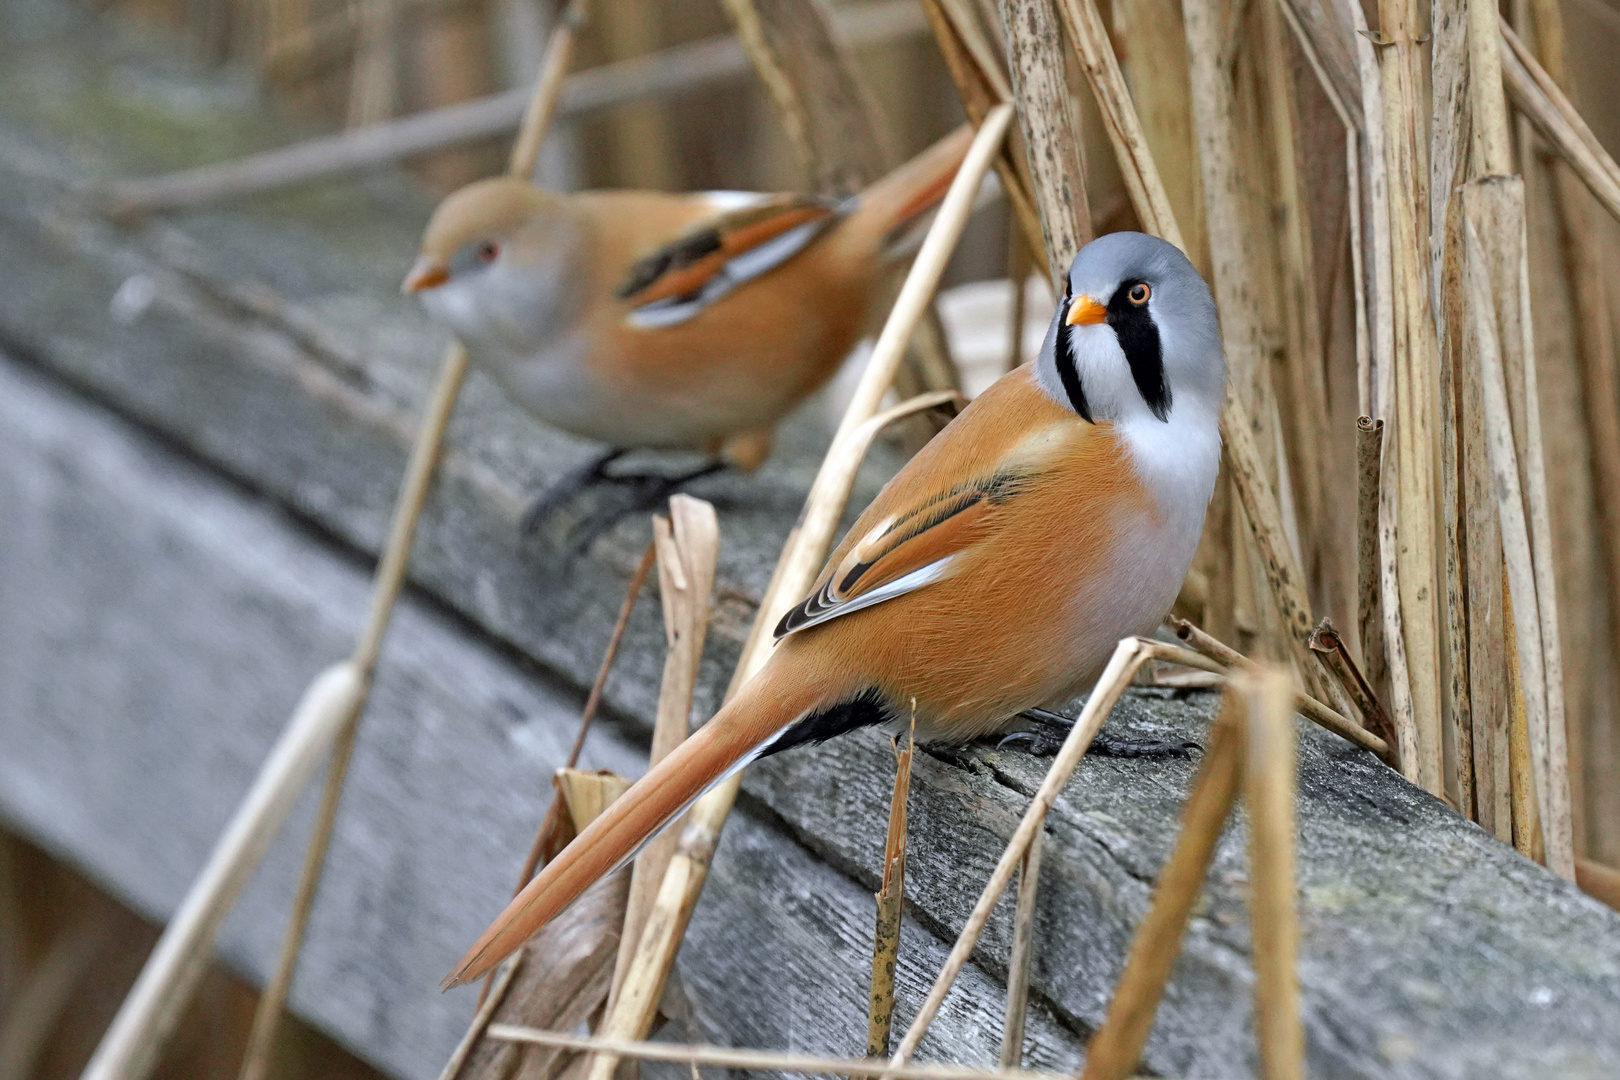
[83,661,365,1080]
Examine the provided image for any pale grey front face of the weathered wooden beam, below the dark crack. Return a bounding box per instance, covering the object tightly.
[0,355,1081,1078]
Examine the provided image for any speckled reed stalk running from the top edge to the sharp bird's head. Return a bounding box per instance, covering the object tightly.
[1000,0,1092,283]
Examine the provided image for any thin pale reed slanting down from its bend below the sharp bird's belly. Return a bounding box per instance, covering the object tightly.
[886,638,1152,1075]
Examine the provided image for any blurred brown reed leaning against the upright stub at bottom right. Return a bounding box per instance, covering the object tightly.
[1081,687,1246,1080]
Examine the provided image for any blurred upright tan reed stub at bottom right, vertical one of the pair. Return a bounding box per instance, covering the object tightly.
[1238,669,1304,1080]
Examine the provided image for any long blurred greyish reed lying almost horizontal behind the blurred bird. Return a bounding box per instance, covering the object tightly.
[102,0,927,219]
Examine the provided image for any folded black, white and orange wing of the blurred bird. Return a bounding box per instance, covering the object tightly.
[616,194,846,327]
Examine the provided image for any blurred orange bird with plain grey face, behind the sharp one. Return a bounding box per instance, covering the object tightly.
[403,126,972,542]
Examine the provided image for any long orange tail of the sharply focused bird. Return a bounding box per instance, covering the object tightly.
[441,654,826,989]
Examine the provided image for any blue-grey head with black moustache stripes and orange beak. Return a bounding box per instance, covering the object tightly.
[1035,233,1226,424]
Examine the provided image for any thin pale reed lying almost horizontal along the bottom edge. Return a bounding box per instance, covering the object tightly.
[488,1023,1071,1080]
